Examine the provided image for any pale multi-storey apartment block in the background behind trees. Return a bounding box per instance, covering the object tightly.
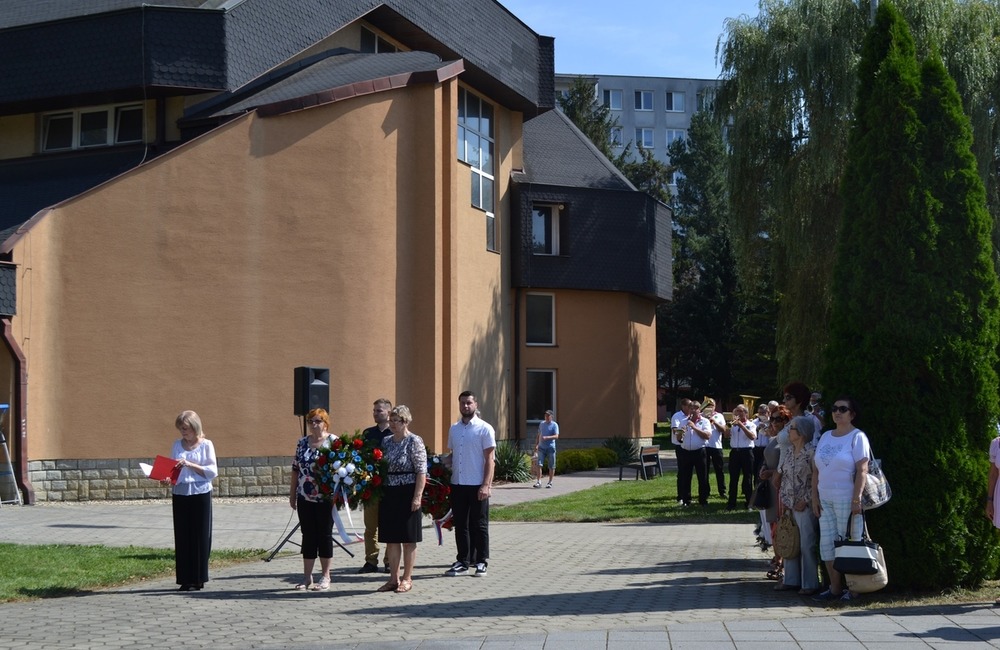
[555,74,719,191]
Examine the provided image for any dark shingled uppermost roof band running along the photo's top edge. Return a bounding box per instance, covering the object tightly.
[0,0,554,115]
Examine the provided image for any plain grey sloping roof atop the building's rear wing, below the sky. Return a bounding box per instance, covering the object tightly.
[516,110,635,190]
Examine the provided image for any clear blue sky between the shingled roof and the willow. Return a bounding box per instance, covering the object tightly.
[499,0,758,79]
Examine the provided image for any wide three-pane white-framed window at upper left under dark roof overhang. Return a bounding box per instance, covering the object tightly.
[40,104,145,151]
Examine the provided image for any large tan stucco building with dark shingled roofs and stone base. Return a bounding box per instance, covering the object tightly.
[0,0,670,500]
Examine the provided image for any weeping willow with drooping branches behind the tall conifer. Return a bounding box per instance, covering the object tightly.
[716,0,1000,385]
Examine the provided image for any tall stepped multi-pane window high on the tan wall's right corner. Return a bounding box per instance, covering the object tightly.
[458,88,499,251]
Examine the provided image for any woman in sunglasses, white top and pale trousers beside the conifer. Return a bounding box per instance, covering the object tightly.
[812,397,872,601]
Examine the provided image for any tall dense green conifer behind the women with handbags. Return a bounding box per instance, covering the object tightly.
[824,1,998,588]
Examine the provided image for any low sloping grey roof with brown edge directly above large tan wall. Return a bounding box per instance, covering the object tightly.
[186,52,461,119]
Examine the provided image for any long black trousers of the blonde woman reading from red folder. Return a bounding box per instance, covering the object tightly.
[171,492,212,586]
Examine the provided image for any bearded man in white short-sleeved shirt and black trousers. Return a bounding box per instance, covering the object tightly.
[445,390,497,578]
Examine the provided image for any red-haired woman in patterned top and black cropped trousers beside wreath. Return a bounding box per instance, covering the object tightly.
[288,408,333,591]
